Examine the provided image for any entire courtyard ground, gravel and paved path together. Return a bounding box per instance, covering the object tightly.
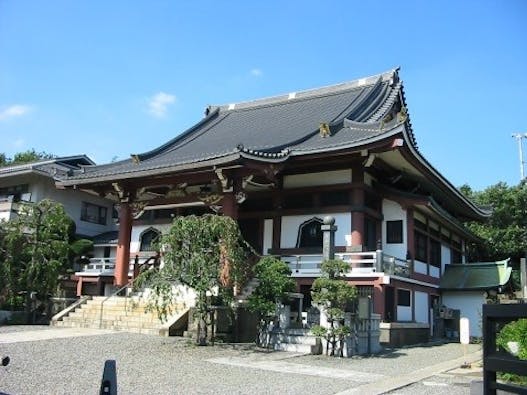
[0,326,481,395]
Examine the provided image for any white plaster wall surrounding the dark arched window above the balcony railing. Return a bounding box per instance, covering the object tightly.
[280,213,351,248]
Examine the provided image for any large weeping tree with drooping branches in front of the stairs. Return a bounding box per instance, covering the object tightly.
[139,214,250,345]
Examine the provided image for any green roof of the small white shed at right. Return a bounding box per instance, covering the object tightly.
[439,259,512,291]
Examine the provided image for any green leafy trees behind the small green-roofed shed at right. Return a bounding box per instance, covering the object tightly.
[460,181,527,262]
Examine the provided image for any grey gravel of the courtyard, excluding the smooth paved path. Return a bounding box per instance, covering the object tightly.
[0,327,484,395]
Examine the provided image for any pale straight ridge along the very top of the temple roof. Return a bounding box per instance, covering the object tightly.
[212,67,399,111]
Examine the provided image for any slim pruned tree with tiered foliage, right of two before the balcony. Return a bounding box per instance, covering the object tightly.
[311,259,357,356]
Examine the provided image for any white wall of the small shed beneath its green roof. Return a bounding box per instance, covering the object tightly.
[442,291,485,337]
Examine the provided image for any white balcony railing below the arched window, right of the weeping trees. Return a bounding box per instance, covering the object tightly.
[280,251,411,277]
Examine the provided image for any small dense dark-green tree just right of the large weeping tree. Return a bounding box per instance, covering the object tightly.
[248,256,295,346]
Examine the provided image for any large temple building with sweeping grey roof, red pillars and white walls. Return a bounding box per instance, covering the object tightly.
[58,69,489,343]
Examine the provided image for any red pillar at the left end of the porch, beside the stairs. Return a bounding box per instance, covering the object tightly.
[114,203,132,287]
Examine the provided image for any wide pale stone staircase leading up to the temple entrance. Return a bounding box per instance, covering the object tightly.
[51,296,189,336]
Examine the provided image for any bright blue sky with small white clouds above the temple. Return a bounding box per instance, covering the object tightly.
[0,0,527,190]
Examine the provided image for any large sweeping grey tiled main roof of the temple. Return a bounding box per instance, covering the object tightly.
[66,70,413,184]
